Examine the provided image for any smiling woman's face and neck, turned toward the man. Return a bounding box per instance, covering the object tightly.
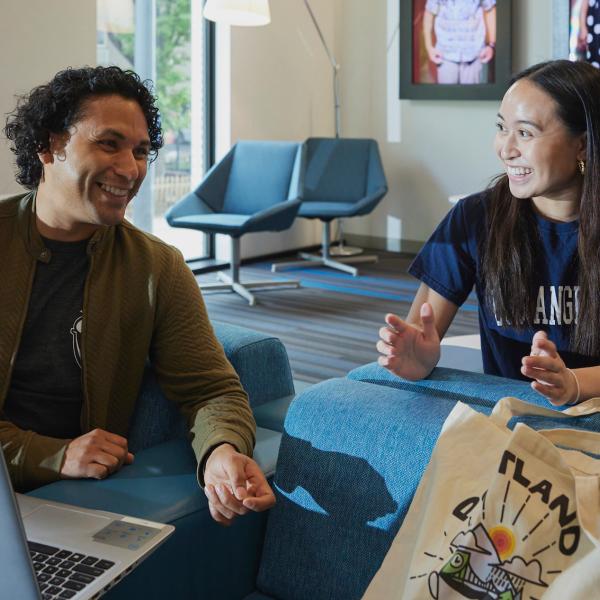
[494,79,585,212]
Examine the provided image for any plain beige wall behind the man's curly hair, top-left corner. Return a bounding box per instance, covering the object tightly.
[0,0,96,195]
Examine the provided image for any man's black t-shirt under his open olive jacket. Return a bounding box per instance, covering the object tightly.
[4,239,89,439]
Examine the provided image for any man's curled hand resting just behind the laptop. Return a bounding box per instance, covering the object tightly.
[60,429,133,479]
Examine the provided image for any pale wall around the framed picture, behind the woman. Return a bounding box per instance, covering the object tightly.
[336,0,552,249]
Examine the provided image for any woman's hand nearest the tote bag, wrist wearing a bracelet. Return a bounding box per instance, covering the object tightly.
[521,331,578,406]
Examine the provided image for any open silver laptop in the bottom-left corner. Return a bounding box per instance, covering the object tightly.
[0,451,175,600]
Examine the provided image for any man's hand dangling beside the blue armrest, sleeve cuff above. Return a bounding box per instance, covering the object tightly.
[204,444,275,525]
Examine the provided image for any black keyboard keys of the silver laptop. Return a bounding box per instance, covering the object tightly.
[27,542,115,600]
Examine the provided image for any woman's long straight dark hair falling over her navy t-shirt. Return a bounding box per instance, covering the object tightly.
[482,60,600,356]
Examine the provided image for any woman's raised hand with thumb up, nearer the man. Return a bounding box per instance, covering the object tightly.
[377,302,440,381]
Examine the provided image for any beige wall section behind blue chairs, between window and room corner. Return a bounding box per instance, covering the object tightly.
[217,0,340,258]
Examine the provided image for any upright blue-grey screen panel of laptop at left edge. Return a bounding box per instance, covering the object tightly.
[0,450,40,600]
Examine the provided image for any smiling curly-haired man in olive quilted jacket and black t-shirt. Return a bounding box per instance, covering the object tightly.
[0,67,274,524]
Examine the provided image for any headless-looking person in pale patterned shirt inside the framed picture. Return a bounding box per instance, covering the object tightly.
[423,0,496,85]
